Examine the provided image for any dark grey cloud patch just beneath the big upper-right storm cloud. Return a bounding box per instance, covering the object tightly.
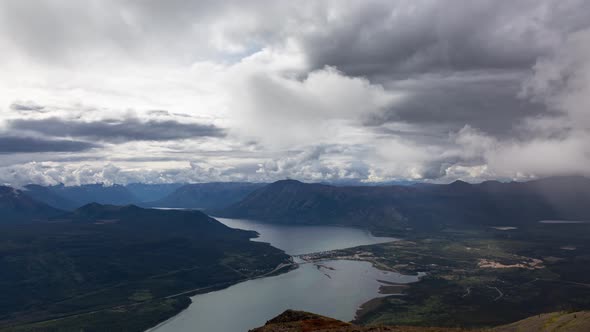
[366,73,546,136]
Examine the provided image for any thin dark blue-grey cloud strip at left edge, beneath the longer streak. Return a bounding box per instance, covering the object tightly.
[0,136,98,154]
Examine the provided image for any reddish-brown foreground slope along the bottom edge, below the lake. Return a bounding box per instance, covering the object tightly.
[250,310,590,332]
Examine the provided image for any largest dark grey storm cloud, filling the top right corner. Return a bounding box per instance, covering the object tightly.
[303,0,590,78]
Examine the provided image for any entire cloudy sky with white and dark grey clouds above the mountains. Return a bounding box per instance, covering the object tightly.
[0,0,590,186]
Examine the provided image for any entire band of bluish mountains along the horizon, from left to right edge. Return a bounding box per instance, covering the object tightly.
[8,177,590,232]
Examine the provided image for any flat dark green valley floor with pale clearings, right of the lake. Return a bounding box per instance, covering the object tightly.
[308,224,590,327]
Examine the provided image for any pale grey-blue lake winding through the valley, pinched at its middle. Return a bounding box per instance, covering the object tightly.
[150,218,418,332]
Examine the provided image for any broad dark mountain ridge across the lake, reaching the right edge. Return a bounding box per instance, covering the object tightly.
[220,177,590,231]
